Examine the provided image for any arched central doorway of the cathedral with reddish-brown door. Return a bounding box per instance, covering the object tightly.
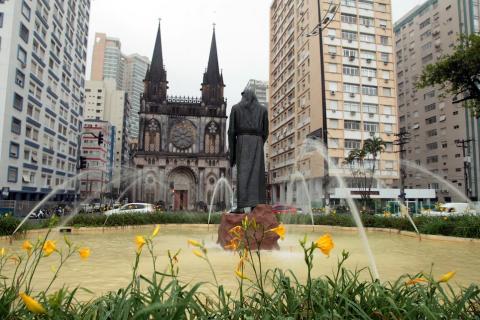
[168,167,197,211]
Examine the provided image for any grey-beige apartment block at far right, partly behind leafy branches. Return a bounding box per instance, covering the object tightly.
[394,0,480,201]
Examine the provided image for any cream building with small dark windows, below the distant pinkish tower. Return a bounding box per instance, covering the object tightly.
[85,79,130,194]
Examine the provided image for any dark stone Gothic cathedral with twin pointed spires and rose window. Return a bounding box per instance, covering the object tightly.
[132,26,229,210]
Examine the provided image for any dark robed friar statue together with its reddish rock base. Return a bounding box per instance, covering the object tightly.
[218,90,279,250]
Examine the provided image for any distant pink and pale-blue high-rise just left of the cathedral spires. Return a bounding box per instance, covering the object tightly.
[91,33,150,139]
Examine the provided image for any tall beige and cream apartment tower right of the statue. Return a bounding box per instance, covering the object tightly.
[269,0,399,202]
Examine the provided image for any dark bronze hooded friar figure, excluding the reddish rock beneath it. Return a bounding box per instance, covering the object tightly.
[228,90,268,208]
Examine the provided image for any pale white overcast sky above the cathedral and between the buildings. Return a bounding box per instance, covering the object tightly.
[87,0,423,107]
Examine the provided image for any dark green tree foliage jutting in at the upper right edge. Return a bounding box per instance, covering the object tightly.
[416,34,480,118]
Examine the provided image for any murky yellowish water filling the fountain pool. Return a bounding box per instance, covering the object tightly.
[0,225,480,295]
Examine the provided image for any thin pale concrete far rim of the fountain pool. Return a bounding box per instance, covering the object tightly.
[0,223,480,243]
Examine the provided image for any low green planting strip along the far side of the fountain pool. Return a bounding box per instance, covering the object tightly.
[0,212,480,239]
